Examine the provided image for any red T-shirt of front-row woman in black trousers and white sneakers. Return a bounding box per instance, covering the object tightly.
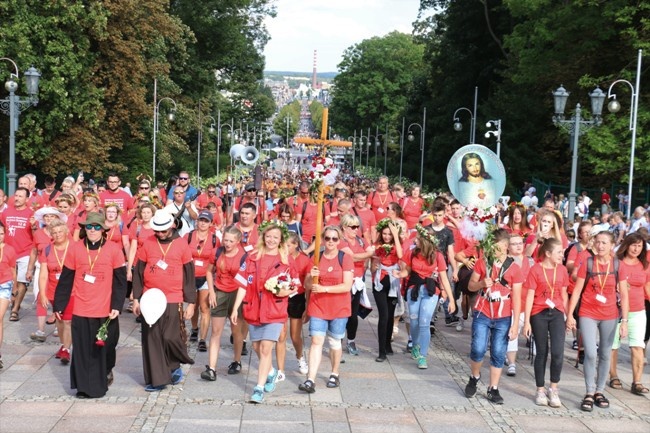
[522,263,569,316]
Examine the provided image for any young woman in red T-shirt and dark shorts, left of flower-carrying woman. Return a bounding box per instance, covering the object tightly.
[201,225,248,381]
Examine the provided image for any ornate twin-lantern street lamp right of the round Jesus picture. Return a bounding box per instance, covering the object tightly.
[553,86,605,219]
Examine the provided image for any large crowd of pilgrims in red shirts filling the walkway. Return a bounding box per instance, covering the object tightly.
[0,172,650,411]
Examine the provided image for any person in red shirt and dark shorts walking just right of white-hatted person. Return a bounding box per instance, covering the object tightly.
[184,210,220,352]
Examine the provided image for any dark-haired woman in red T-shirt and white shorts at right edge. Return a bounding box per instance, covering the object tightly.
[609,232,650,395]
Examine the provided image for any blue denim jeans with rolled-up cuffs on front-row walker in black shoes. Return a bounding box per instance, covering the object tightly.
[469,311,512,368]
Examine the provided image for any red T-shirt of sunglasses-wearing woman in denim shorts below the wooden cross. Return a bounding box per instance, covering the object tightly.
[307,254,354,320]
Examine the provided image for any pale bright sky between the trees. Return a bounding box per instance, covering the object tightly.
[264,0,420,72]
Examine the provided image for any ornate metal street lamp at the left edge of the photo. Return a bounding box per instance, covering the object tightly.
[0,57,41,195]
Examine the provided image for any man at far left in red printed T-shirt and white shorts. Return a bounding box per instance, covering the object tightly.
[0,187,34,322]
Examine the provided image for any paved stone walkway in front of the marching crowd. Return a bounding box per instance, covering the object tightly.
[0,296,650,433]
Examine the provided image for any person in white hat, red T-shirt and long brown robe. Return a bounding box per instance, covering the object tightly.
[133,209,196,392]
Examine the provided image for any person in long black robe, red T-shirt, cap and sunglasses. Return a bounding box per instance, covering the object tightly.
[54,212,126,398]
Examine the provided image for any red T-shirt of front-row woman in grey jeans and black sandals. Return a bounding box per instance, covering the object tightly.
[578,257,620,320]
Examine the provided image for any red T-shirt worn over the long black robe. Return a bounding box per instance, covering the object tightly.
[67,240,124,318]
